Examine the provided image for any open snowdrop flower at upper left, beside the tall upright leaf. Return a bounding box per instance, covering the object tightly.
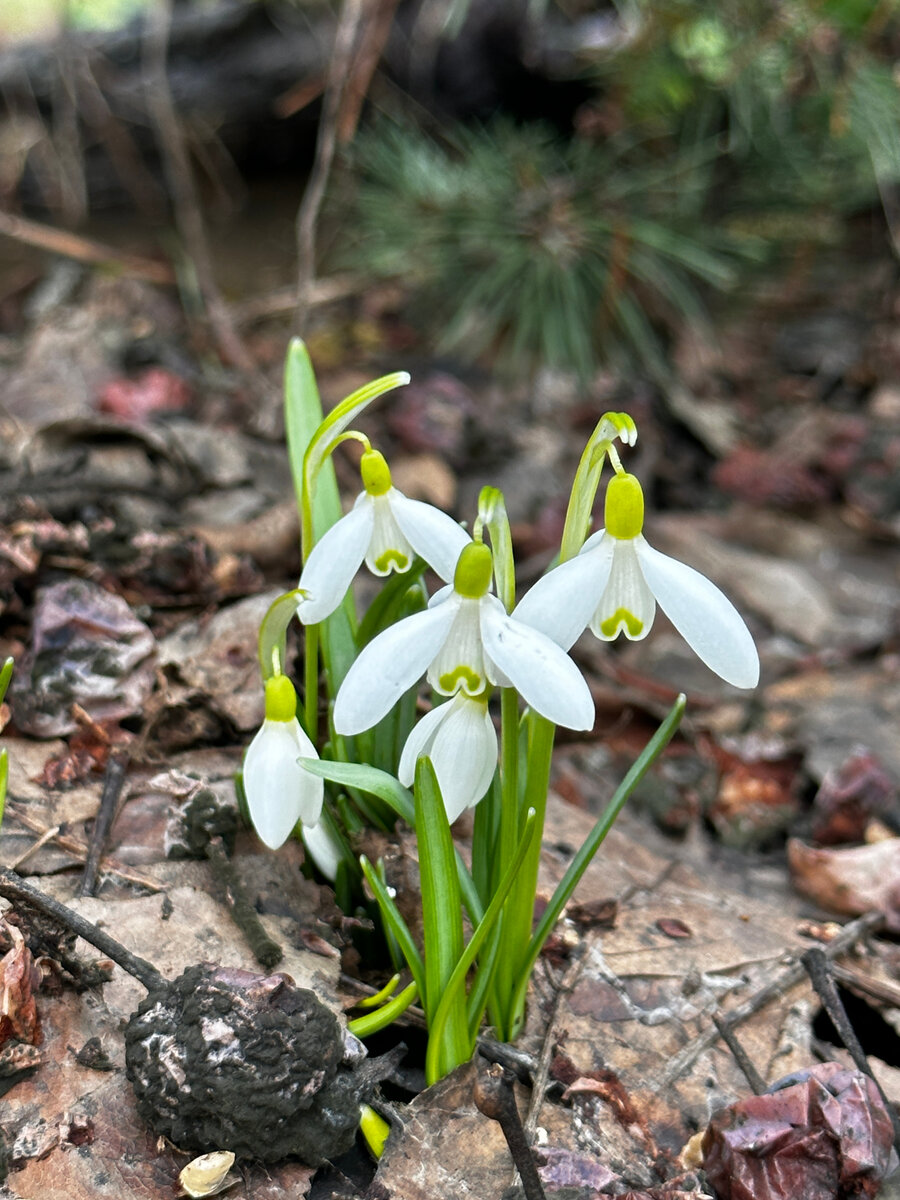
[296,449,472,625]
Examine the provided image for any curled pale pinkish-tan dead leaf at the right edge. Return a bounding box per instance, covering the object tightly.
[787,838,900,932]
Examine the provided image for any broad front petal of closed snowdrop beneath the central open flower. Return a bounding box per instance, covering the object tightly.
[430,694,497,824]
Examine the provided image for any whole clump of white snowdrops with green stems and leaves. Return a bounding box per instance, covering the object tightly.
[244,341,758,1081]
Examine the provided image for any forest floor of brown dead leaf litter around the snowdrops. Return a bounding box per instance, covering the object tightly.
[0,189,900,1200]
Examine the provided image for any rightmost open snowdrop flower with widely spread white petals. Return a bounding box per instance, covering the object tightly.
[512,473,760,688]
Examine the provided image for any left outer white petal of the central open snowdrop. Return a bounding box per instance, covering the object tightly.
[334,596,458,734]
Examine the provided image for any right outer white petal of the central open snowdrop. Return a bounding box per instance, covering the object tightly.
[481,596,594,730]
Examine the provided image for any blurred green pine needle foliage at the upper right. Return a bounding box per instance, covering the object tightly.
[341,0,900,377]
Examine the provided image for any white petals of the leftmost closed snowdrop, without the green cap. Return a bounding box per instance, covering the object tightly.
[244,721,324,850]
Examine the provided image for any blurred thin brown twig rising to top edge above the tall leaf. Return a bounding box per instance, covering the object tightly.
[294,0,364,334]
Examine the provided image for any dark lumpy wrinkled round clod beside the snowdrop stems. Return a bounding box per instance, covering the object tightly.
[125,965,361,1166]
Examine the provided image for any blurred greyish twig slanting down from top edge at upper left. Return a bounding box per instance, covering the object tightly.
[143,0,254,374]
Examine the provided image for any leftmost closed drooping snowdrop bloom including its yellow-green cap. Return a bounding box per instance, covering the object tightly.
[244,674,325,850]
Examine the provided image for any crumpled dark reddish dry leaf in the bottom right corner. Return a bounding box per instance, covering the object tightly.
[703,1062,894,1200]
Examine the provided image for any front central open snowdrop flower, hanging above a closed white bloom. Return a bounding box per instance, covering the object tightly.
[334,542,594,734]
